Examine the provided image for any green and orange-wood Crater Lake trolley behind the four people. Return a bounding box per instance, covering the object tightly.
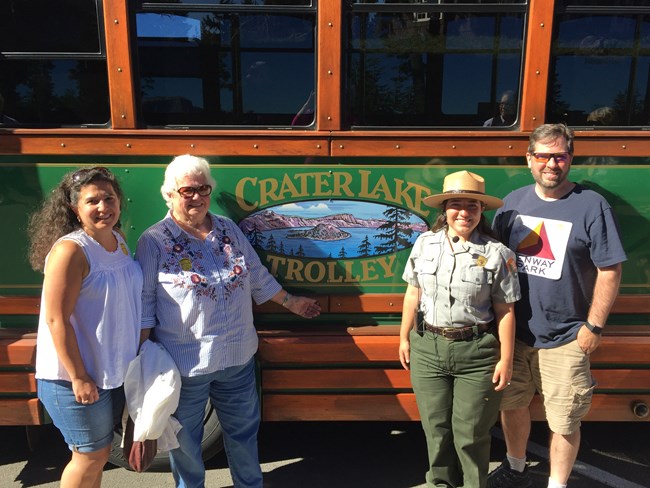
[0,0,650,466]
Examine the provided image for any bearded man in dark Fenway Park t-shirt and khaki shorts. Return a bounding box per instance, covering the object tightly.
[488,124,627,488]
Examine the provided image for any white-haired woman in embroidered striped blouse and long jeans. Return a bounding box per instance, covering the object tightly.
[136,155,320,488]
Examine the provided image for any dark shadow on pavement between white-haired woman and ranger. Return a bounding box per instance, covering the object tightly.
[260,422,427,488]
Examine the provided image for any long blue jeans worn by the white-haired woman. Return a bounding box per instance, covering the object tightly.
[169,358,262,488]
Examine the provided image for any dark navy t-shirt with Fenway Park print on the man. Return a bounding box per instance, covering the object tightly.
[494,185,627,348]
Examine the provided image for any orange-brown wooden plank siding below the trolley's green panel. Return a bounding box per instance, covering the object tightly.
[0,294,650,426]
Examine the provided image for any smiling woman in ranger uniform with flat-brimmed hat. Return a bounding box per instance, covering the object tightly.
[399,171,520,488]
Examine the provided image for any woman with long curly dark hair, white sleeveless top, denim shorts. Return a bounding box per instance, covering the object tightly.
[29,167,142,488]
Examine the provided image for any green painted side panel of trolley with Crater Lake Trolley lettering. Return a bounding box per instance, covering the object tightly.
[0,156,650,295]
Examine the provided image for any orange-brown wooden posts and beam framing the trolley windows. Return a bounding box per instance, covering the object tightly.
[0,0,650,164]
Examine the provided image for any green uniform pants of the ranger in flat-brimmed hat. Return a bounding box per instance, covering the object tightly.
[410,331,501,488]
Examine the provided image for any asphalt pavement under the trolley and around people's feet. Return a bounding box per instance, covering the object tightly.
[0,422,650,488]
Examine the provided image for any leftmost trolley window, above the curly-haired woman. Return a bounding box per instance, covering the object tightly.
[0,0,110,127]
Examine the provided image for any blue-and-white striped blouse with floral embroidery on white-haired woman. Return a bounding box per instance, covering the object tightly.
[135,213,282,376]
